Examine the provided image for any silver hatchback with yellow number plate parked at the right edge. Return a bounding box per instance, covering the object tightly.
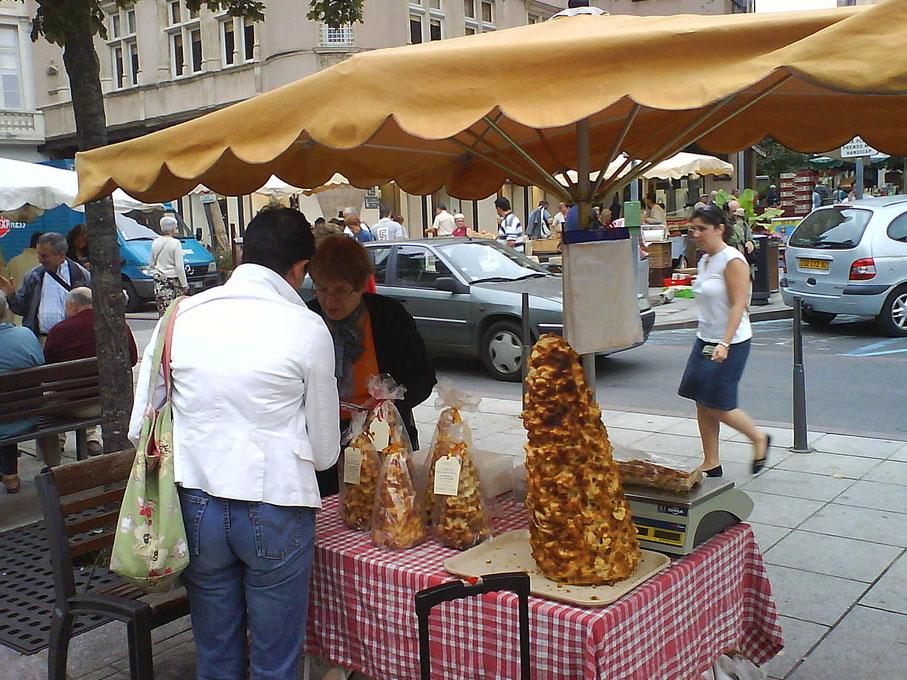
[781,196,907,336]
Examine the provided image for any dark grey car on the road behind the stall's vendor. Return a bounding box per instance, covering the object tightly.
[302,238,655,381]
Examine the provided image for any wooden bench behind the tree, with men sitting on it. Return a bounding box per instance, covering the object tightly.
[0,358,101,460]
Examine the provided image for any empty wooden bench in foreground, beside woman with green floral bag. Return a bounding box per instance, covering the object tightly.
[35,451,189,680]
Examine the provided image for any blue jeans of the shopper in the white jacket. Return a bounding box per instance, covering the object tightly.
[179,488,315,680]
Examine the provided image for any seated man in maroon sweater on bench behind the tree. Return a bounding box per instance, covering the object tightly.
[38,287,138,466]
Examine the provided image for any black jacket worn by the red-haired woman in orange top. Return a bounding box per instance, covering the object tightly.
[308,293,437,449]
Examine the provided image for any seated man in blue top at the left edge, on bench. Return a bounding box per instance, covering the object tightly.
[0,295,44,493]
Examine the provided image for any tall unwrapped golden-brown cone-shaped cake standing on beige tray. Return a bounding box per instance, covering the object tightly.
[523,334,639,585]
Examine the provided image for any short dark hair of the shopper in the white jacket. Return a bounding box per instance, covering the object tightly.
[243,208,315,276]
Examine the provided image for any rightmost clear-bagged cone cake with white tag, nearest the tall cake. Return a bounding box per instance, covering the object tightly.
[425,379,492,550]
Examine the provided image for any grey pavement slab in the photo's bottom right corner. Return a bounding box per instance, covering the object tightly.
[788,605,907,680]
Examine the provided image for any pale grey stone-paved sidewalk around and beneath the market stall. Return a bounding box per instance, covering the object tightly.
[0,399,907,680]
